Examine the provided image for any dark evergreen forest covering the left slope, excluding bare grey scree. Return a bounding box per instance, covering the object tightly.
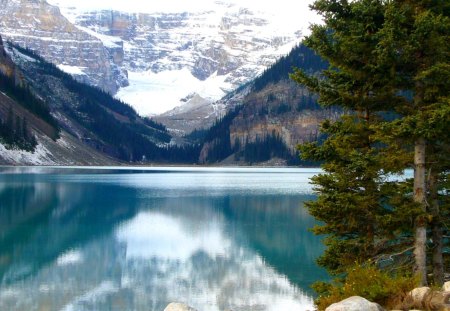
[0,37,206,163]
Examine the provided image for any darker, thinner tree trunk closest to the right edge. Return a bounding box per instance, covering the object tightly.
[429,171,444,286]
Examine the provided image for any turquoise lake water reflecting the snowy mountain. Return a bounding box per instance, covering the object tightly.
[0,168,327,311]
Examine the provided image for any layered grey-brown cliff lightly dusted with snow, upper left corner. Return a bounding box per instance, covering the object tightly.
[0,0,127,93]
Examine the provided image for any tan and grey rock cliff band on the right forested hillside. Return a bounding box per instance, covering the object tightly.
[230,80,339,152]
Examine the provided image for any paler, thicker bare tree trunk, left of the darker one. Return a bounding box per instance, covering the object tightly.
[414,138,427,286]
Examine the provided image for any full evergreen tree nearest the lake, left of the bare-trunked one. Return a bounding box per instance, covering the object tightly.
[292,0,417,273]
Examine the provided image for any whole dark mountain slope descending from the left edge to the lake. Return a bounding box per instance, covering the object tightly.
[0,35,185,164]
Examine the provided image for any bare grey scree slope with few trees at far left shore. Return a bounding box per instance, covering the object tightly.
[0,37,117,165]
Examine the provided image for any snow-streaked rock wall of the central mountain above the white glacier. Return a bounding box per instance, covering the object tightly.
[66,8,300,84]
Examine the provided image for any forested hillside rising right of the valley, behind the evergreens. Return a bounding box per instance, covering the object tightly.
[195,45,338,165]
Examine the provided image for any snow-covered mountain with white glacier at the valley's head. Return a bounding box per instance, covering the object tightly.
[50,0,320,114]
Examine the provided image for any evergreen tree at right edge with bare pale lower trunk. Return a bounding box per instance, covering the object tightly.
[380,1,450,285]
